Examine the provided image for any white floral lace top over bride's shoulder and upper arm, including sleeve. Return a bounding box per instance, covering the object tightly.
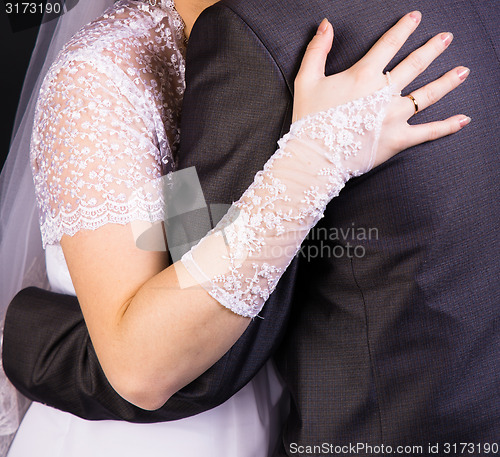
[31,0,185,246]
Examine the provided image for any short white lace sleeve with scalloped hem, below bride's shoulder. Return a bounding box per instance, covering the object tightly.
[31,61,172,247]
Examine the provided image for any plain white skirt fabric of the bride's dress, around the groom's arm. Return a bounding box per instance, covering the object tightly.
[8,246,284,457]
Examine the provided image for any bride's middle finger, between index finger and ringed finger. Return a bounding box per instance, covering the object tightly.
[391,32,453,89]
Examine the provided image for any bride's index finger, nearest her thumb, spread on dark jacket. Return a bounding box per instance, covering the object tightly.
[360,11,422,71]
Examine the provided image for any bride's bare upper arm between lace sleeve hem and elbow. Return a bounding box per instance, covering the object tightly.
[61,224,167,344]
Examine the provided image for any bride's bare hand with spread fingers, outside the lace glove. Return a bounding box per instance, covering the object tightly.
[293,11,470,166]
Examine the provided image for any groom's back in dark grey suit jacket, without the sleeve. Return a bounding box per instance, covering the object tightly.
[223,0,500,455]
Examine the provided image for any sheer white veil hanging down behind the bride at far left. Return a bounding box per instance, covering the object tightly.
[0,0,114,457]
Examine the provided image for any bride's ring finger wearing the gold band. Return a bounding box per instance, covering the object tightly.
[400,67,469,119]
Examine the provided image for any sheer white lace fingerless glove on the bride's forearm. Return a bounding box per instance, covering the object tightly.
[181,84,395,317]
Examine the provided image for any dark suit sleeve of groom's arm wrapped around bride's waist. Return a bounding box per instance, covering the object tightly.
[3,5,295,422]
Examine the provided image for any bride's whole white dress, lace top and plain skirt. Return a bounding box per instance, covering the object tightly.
[8,0,282,457]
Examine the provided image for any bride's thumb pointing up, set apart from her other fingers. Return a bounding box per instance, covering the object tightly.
[297,19,333,82]
